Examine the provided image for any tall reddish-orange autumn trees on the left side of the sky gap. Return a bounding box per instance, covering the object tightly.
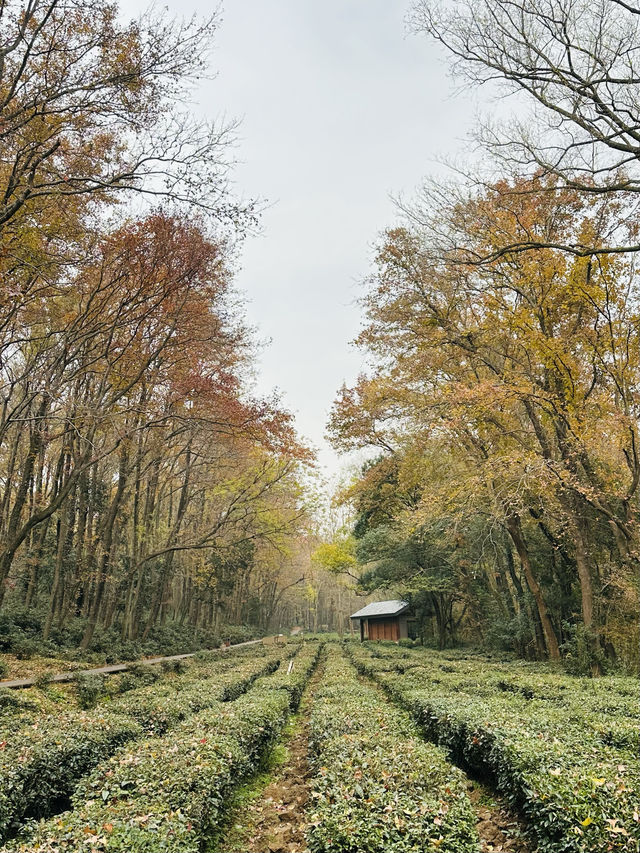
[0,0,310,649]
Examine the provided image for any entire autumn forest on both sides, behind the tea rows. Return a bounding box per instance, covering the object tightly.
[0,0,640,673]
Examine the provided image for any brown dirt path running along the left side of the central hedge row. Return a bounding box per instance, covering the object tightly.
[216,661,324,853]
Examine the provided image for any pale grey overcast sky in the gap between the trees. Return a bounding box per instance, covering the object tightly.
[127,0,482,475]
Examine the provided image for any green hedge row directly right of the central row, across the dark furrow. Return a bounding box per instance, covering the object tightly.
[353,649,640,853]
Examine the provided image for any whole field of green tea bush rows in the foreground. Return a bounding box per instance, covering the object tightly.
[0,640,640,853]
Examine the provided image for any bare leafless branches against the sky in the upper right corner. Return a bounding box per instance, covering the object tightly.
[410,0,640,255]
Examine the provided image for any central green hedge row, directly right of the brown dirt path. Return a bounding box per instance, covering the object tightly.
[307,648,479,853]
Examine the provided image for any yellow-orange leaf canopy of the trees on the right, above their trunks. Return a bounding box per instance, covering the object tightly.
[329,168,640,660]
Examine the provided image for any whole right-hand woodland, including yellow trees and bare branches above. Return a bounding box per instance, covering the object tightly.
[324,0,640,674]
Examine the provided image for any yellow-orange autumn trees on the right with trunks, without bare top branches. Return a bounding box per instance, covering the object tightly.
[331,178,640,669]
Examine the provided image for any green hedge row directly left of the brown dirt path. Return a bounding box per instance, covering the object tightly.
[6,650,317,853]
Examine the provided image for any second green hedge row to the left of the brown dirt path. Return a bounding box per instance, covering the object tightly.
[0,653,279,841]
